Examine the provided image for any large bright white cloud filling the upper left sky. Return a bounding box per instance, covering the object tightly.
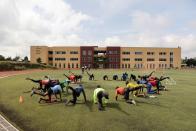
[0,0,91,57]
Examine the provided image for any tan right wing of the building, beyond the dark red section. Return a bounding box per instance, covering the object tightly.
[121,47,181,69]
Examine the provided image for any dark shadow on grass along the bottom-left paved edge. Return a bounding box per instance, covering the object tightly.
[0,104,37,131]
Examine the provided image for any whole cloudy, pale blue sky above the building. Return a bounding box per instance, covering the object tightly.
[0,0,196,58]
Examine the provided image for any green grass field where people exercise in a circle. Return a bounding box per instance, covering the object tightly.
[0,70,196,131]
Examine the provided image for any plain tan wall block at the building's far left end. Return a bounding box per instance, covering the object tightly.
[30,46,48,64]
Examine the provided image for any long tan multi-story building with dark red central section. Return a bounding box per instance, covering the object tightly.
[31,46,181,69]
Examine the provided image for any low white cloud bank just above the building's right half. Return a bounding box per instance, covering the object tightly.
[103,33,196,58]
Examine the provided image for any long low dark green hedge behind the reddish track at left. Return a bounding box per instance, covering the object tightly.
[0,61,56,71]
